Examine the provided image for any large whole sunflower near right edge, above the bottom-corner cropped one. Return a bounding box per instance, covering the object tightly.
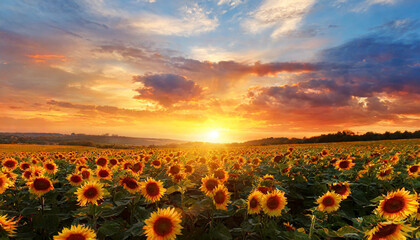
[376,188,419,221]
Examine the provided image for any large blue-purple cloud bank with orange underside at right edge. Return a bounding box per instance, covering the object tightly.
[238,32,420,128]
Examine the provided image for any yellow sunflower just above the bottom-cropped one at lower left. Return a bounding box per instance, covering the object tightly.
[75,181,104,206]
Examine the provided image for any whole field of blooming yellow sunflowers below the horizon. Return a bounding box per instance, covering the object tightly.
[0,139,420,240]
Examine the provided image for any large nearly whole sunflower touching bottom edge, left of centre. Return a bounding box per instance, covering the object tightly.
[144,208,182,240]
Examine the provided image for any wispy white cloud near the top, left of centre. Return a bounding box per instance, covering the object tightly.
[130,4,219,36]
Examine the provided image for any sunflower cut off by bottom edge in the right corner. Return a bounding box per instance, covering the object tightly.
[365,222,415,240]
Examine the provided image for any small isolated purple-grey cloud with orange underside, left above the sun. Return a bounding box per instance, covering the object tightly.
[133,74,203,107]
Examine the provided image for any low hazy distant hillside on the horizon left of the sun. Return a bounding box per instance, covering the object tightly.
[0,133,184,147]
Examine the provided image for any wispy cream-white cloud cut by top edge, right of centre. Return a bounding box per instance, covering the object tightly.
[242,0,315,38]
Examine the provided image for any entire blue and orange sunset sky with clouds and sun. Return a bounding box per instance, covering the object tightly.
[0,0,420,142]
